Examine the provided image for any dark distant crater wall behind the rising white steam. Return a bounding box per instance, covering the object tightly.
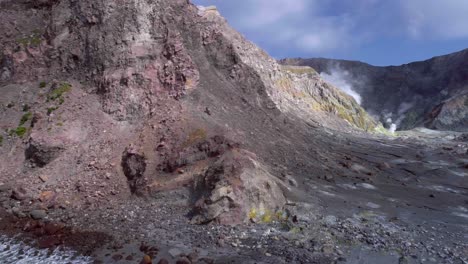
[282,50,468,131]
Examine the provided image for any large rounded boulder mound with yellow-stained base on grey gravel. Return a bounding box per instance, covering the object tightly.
[192,149,286,224]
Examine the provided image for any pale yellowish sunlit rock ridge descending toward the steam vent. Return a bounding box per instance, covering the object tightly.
[203,10,376,130]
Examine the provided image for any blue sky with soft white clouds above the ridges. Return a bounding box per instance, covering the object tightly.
[192,0,468,65]
